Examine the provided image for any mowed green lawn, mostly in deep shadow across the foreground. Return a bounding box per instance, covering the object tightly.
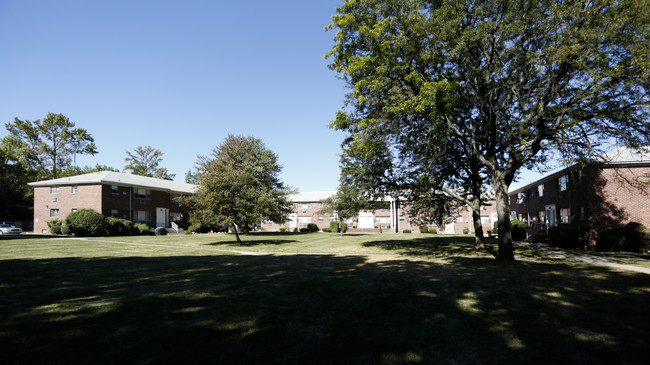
[0,233,650,364]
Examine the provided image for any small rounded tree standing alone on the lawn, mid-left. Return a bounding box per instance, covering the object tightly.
[189,135,293,243]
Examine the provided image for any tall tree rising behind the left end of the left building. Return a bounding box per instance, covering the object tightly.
[5,113,97,179]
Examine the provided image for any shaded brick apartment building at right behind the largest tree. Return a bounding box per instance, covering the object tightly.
[509,148,650,232]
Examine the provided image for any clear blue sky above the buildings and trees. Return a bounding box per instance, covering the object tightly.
[0,0,548,191]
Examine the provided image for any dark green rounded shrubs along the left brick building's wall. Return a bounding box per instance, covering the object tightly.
[47,209,154,237]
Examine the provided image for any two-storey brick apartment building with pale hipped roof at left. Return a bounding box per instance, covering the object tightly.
[29,171,196,233]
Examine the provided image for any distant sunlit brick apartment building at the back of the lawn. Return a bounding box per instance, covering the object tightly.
[262,191,496,234]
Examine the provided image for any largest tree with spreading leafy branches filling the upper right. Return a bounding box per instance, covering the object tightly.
[328,0,650,261]
